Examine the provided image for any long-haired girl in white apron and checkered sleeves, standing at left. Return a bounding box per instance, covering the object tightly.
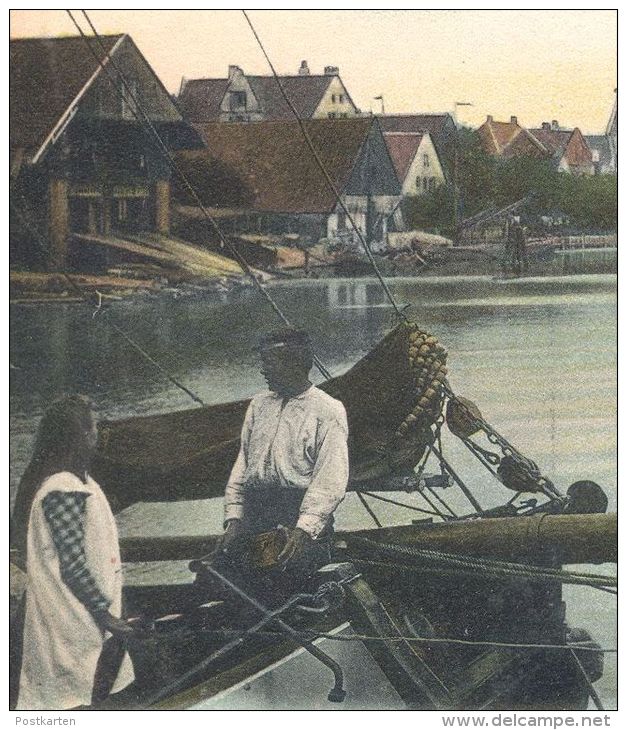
[13,395,134,710]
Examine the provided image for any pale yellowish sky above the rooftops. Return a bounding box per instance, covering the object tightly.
[10,10,617,134]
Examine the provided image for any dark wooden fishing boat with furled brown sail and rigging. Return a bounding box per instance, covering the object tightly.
[54,321,617,710]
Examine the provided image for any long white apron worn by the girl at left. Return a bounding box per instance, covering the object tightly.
[16,472,134,710]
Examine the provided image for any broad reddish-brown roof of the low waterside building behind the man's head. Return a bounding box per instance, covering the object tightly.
[178,118,374,213]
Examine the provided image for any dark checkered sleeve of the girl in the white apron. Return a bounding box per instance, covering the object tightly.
[42,492,111,611]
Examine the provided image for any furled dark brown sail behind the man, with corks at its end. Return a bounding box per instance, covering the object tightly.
[94,322,446,511]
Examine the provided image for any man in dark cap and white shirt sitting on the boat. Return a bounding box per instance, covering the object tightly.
[220,329,348,592]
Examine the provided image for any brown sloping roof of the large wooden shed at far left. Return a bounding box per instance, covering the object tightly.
[9,35,123,155]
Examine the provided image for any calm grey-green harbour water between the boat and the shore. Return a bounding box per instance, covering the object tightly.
[10,275,616,708]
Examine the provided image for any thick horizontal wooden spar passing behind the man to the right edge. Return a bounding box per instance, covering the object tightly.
[120,513,618,564]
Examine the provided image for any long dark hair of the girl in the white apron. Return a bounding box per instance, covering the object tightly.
[11,395,93,555]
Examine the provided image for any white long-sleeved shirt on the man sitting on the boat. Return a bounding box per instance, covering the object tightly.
[224,386,348,538]
